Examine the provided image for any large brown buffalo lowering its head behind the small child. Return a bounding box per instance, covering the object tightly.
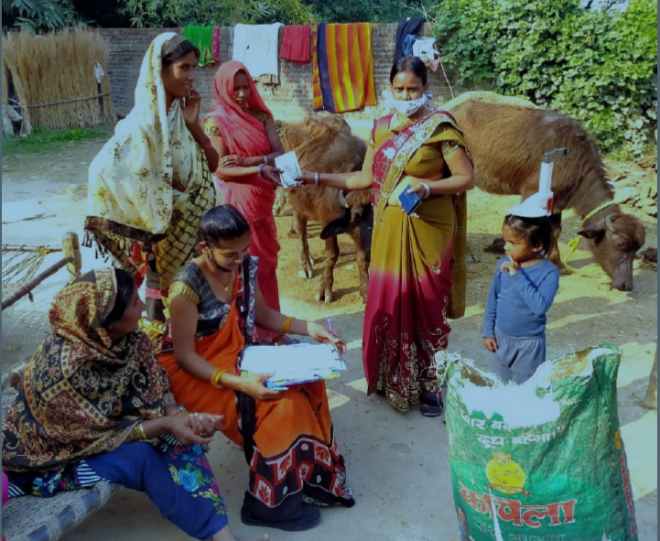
[447,93,645,291]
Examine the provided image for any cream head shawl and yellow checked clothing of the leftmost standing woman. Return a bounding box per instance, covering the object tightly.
[85,32,215,288]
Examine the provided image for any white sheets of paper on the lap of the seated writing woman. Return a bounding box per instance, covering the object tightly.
[241,344,346,383]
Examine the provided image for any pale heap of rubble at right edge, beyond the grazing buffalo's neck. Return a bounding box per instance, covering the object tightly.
[605,156,658,217]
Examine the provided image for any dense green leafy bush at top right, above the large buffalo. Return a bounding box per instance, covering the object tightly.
[434,0,658,154]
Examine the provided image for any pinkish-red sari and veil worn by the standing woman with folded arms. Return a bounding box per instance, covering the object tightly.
[204,60,280,316]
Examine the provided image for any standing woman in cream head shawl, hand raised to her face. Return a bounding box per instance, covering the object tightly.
[85,33,219,320]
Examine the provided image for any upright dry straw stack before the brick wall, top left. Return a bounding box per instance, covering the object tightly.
[2,28,115,130]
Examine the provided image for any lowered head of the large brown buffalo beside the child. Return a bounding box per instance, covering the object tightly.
[579,210,646,291]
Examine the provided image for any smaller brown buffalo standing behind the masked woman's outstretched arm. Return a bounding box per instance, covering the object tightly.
[280,116,373,302]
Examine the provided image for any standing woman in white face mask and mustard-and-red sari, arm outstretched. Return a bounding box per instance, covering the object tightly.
[300,57,474,417]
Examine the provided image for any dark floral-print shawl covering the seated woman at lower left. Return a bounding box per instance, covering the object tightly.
[2,269,174,471]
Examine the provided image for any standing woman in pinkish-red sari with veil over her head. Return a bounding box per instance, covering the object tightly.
[203,61,284,339]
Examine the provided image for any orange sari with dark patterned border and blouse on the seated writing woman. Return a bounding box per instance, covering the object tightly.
[158,257,355,520]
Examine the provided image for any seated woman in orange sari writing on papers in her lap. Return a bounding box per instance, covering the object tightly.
[159,205,355,531]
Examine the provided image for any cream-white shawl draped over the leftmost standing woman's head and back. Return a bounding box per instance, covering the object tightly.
[87,32,196,235]
